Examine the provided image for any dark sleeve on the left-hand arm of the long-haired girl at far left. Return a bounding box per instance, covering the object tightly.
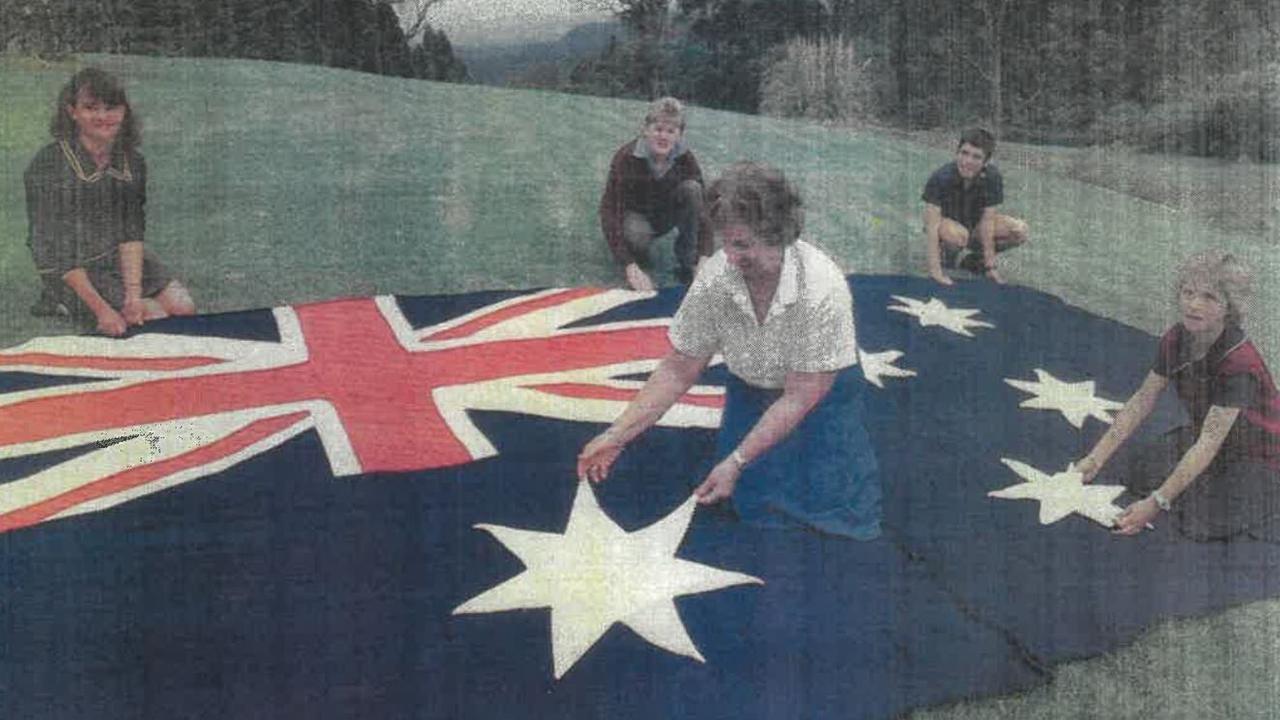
[23,152,77,278]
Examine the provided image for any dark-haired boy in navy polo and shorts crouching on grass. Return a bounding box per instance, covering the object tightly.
[922,128,1028,284]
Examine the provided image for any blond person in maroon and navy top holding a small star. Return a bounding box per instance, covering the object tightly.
[1076,250,1280,539]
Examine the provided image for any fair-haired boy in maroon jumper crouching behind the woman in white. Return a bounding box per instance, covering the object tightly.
[600,97,714,291]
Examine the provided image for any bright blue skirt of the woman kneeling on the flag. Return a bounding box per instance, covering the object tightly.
[716,365,881,539]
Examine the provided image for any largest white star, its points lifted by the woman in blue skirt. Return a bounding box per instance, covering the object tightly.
[453,483,763,679]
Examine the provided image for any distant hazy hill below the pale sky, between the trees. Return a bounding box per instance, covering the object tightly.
[453,20,626,85]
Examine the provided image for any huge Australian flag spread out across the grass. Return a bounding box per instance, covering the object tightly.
[0,277,1280,719]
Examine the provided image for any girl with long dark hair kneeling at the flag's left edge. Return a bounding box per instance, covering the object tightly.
[23,68,195,336]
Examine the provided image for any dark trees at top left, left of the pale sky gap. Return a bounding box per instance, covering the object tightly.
[0,0,466,82]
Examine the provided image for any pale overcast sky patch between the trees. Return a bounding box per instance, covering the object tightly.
[414,0,600,42]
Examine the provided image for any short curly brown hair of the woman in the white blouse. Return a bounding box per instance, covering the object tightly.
[707,161,804,246]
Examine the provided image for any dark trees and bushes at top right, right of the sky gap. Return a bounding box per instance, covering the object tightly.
[573,0,1280,161]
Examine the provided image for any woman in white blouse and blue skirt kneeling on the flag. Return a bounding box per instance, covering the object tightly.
[577,163,881,539]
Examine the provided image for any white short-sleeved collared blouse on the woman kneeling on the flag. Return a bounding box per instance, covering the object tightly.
[667,240,858,388]
